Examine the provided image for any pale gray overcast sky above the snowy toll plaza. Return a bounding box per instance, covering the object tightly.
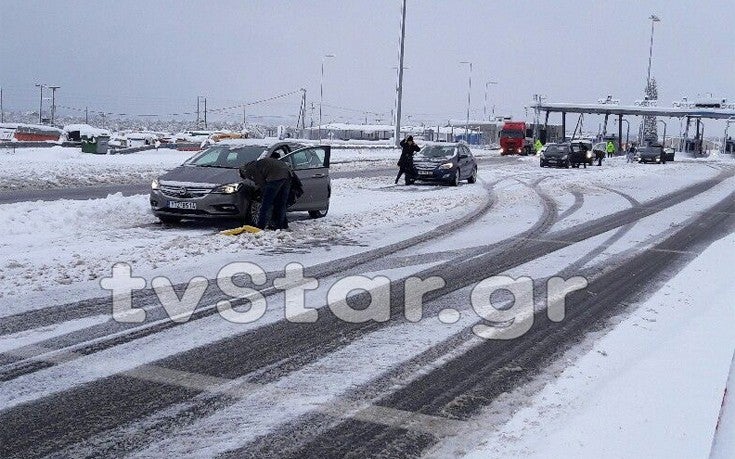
[0,0,735,123]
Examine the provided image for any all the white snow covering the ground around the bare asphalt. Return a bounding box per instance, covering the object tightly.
[0,147,735,457]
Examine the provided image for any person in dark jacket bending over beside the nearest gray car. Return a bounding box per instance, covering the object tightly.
[240,158,292,229]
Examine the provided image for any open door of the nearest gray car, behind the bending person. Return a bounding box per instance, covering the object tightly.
[283,146,331,210]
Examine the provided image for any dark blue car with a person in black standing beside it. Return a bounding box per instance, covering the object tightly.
[413,143,477,186]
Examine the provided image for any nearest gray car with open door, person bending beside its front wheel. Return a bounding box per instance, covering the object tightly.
[150,140,331,224]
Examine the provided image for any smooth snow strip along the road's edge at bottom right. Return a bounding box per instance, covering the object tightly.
[433,234,735,458]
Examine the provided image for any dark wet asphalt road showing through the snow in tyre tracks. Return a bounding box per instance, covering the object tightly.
[0,164,735,458]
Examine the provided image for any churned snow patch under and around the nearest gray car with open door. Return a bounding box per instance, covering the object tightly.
[0,178,485,306]
